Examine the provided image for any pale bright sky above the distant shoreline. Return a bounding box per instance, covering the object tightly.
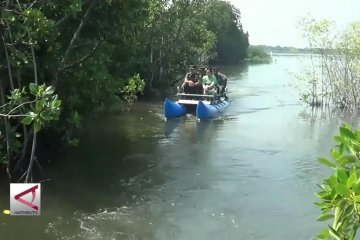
[228,0,360,47]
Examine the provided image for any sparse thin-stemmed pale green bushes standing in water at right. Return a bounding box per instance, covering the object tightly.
[299,19,360,111]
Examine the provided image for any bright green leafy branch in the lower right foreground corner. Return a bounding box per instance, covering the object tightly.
[316,125,360,240]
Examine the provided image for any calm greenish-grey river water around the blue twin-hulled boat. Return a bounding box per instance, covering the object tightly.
[0,56,357,240]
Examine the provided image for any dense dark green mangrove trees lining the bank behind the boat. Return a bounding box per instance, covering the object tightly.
[0,0,248,182]
